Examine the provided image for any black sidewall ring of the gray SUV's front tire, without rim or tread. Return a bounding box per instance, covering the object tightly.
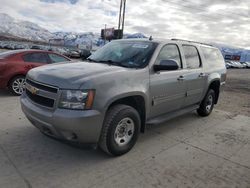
[107,108,141,156]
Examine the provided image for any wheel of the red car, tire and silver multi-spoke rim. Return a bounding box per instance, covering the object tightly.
[9,76,25,96]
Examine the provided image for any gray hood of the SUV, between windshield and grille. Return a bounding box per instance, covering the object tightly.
[27,62,126,89]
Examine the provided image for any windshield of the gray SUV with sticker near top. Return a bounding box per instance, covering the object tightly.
[88,41,157,68]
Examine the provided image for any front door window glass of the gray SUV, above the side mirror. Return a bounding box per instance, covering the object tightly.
[156,44,182,68]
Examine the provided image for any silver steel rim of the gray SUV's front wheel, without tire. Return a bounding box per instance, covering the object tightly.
[114,117,135,146]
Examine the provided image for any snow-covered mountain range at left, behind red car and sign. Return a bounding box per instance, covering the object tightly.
[0,13,146,46]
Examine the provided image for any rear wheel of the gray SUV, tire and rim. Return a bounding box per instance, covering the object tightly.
[197,89,215,117]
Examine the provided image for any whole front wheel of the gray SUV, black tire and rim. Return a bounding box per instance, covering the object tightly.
[99,104,141,156]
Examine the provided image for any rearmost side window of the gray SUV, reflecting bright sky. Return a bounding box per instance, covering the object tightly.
[201,47,223,66]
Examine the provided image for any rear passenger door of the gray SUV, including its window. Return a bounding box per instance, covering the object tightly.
[182,45,207,107]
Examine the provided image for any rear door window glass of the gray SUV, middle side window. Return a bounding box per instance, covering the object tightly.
[182,45,201,69]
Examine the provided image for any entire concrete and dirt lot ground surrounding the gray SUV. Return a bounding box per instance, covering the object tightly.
[0,70,250,188]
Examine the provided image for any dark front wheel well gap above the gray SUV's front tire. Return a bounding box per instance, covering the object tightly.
[108,95,146,132]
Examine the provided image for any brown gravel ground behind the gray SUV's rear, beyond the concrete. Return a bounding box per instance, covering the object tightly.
[216,69,250,116]
